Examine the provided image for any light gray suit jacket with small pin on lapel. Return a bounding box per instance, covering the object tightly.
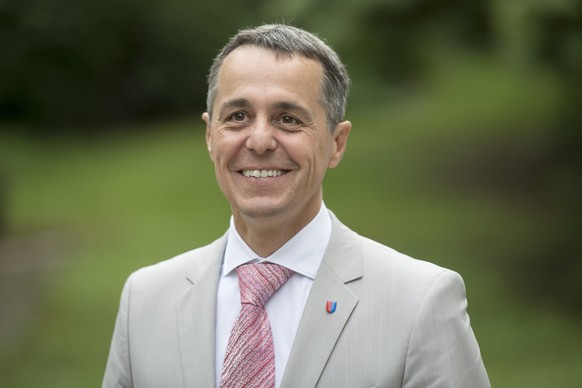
[103,214,490,388]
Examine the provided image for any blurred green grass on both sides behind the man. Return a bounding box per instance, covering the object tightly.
[0,60,582,388]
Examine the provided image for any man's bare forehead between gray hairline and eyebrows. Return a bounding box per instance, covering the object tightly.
[215,45,323,109]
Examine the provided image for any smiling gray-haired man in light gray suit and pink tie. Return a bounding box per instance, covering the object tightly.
[103,25,489,388]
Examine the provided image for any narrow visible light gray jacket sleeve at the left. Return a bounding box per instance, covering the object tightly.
[102,277,133,388]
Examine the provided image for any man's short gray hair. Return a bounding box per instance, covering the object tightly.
[206,24,350,130]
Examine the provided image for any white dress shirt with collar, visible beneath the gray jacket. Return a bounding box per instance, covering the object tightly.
[216,203,331,387]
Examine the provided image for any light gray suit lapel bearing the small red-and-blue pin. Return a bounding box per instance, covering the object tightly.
[281,212,363,388]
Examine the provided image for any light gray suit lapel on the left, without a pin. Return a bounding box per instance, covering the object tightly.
[176,237,226,387]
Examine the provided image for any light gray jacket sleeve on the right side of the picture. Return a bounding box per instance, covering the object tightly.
[402,271,490,388]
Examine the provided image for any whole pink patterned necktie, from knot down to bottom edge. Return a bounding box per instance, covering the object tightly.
[220,263,293,388]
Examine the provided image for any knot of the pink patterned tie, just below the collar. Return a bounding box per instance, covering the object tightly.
[236,263,293,307]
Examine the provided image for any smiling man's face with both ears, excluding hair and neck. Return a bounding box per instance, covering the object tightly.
[203,45,351,228]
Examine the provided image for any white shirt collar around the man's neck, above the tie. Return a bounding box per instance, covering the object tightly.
[222,202,331,279]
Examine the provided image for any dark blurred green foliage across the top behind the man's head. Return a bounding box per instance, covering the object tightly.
[0,0,582,131]
